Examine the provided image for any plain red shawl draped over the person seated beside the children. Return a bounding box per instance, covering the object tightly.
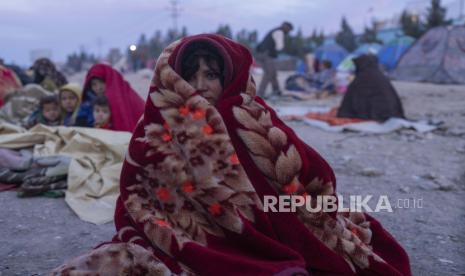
[83,64,145,132]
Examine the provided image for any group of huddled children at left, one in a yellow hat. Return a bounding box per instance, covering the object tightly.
[27,78,111,129]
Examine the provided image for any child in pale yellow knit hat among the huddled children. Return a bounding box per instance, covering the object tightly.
[58,83,82,126]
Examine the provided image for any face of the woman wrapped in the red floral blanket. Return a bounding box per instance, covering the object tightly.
[187,58,223,105]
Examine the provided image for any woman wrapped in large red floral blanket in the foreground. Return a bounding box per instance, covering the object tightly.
[54,35,410,275]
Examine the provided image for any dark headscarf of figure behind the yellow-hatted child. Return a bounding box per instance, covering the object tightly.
[31,58,68,92]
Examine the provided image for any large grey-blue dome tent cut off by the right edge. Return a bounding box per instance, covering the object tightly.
[392,26,465,84]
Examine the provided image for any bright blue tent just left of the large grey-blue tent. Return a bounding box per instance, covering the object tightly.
[378,36,415,71]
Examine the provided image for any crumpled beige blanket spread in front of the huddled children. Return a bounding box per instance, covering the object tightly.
[0,124,131,224]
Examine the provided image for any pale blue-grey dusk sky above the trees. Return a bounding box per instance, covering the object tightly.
[0,0,459,65]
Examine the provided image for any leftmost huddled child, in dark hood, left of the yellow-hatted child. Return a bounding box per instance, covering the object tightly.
[27,95,61,128]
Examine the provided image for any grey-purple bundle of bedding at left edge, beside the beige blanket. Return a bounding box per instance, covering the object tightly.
[0,148,71,197]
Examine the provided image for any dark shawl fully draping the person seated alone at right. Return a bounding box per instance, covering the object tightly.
[337,55,405,121]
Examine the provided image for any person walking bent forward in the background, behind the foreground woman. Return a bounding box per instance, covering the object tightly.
[257,22,294,97]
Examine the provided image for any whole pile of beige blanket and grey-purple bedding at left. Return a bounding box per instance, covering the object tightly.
[0,123,131,224]
